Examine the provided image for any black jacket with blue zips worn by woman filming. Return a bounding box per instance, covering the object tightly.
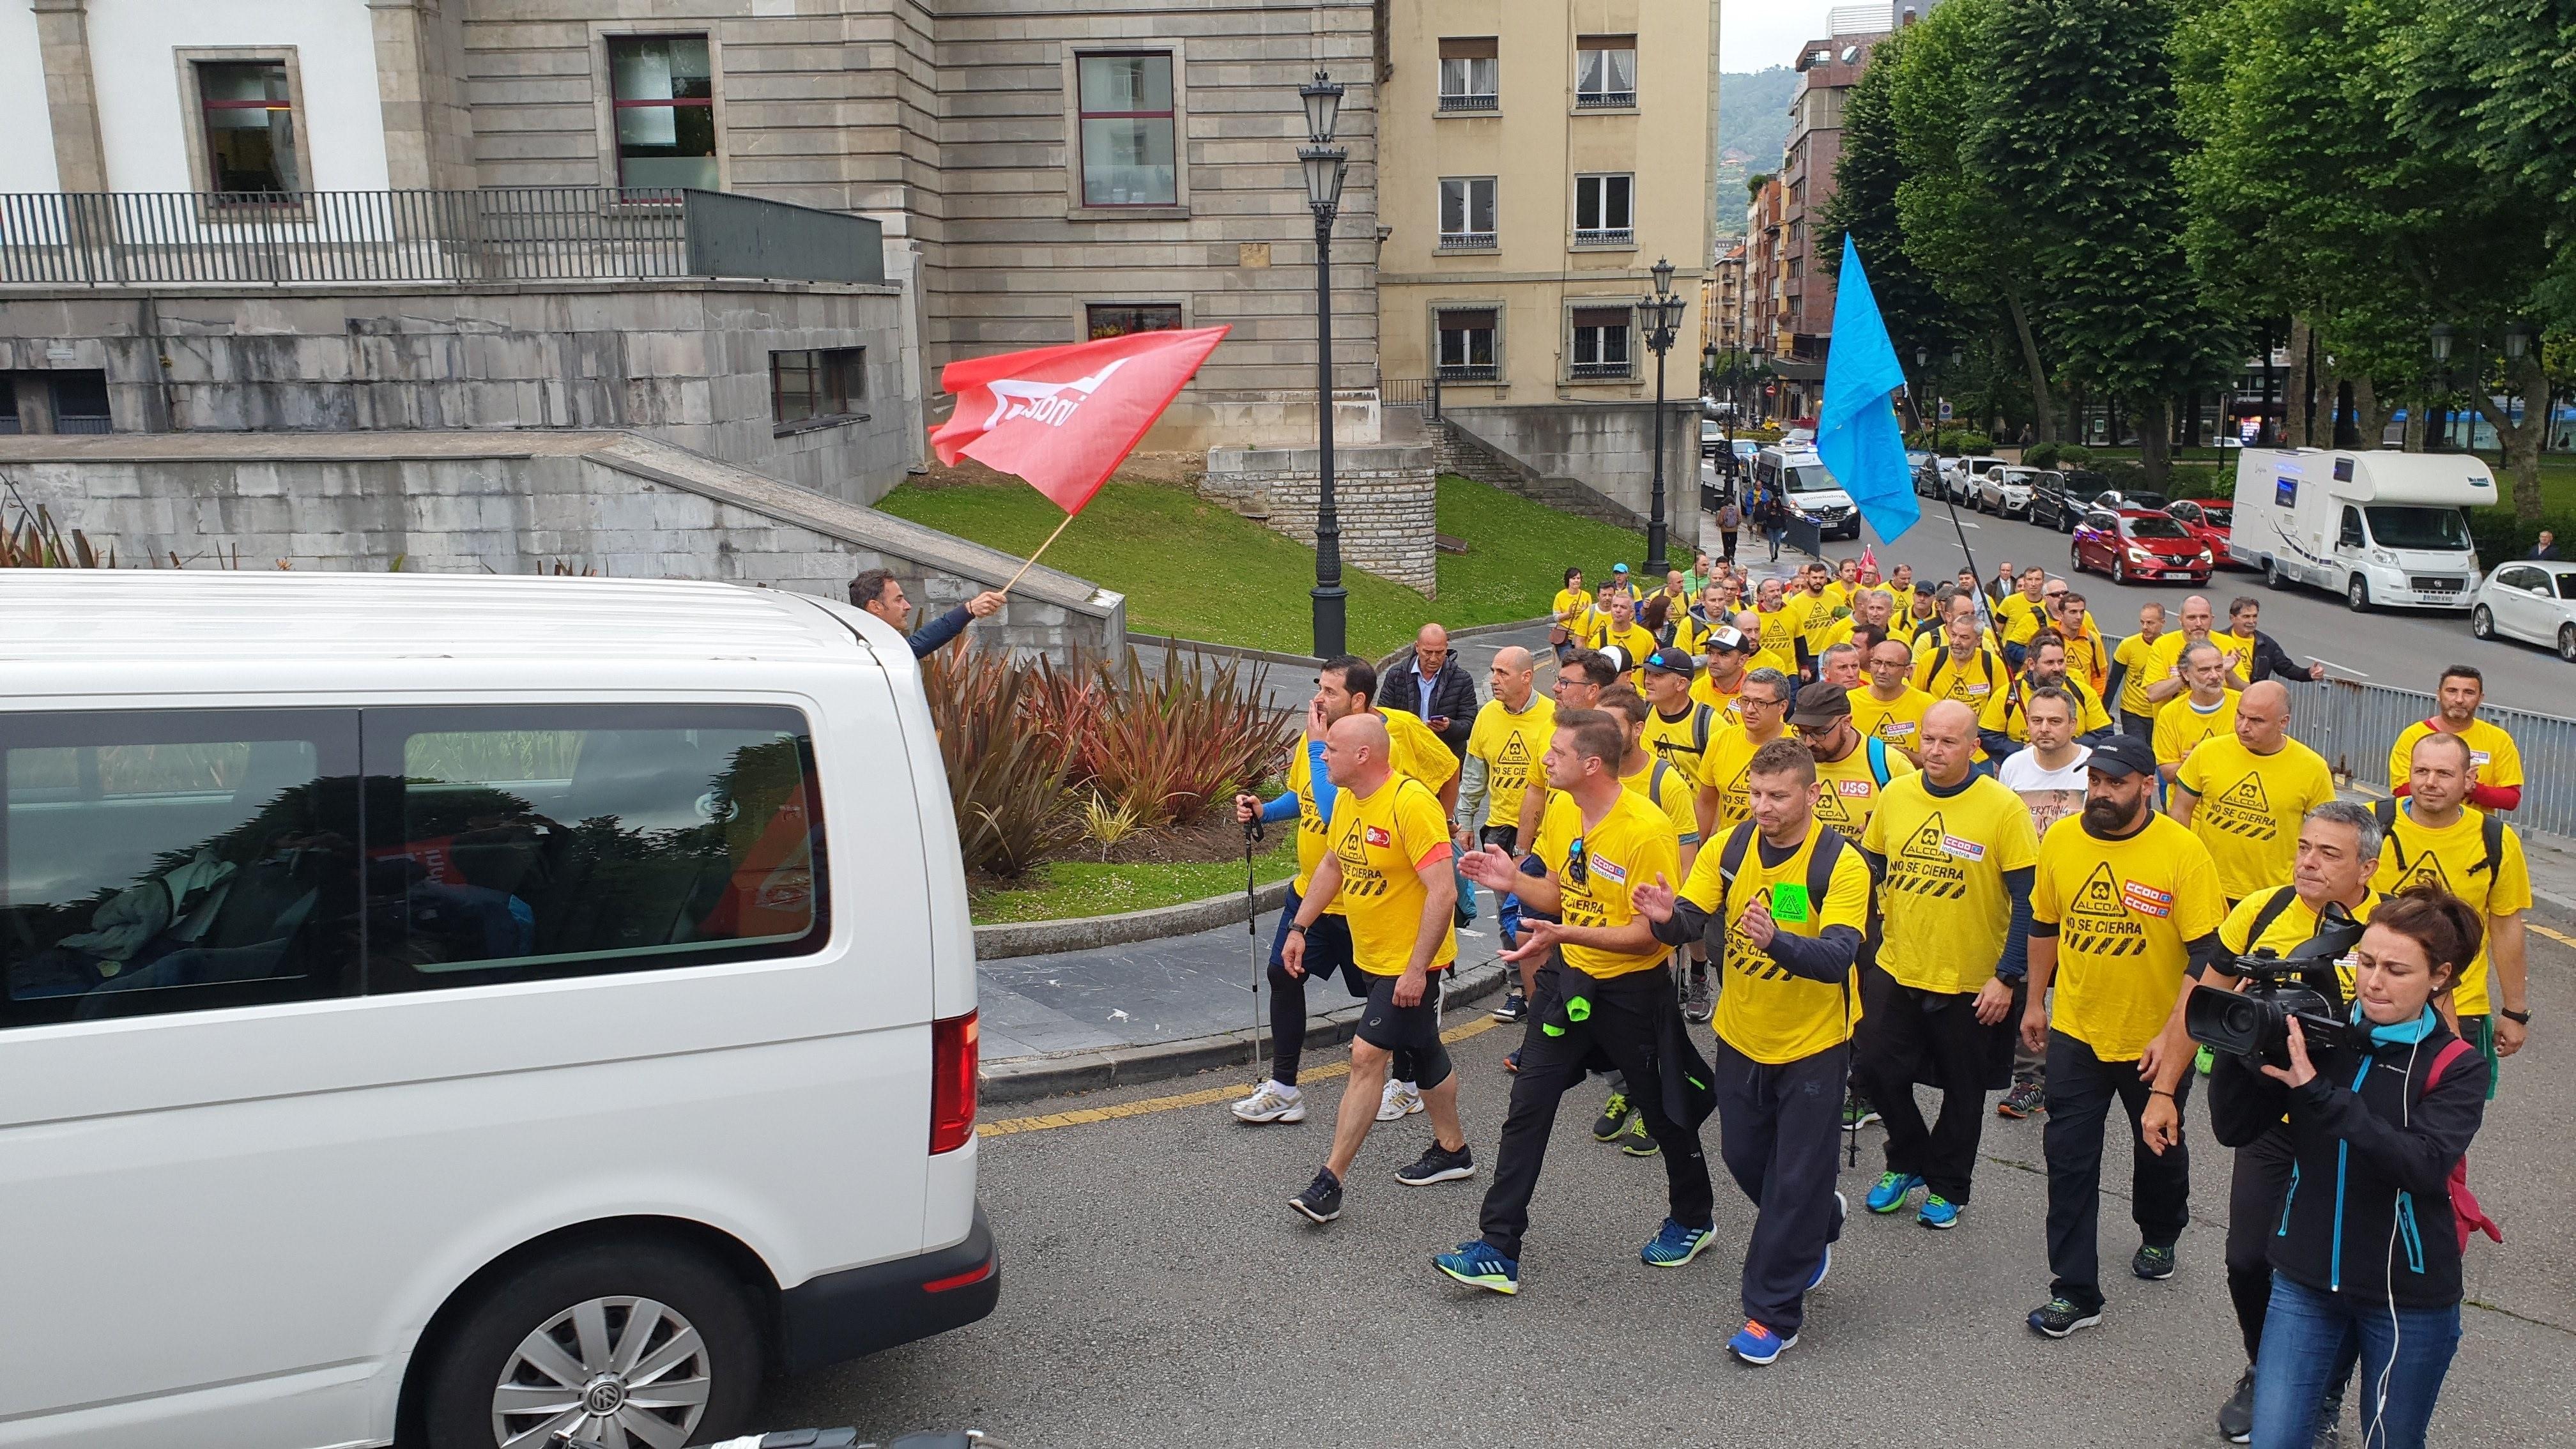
[2210,1026,2486,1307]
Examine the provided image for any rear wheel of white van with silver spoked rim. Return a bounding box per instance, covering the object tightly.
[422,1238,762,1449]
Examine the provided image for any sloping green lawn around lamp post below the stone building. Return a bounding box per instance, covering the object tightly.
[878,477,1646,655]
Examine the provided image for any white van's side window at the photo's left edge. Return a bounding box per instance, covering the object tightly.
[0,709,360,1026]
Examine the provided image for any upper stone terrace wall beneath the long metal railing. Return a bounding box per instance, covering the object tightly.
[0,279,922,503]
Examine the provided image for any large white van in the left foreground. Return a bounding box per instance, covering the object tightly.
[0,570,999,1449]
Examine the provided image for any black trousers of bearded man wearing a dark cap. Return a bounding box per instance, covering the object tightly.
[2040,1031,2192,1312]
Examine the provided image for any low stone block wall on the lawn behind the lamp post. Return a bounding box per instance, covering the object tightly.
[1198,446,1440,598]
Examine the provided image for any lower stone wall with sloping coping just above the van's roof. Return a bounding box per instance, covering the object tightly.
[0,433,1126,660]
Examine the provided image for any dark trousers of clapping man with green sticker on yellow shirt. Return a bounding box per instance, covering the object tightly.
[1708,1026,1852,1338]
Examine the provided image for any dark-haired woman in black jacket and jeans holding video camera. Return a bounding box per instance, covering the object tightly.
[2210,887,2486,1449]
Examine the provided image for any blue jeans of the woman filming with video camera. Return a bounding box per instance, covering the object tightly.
[2254,1274,2460,1449]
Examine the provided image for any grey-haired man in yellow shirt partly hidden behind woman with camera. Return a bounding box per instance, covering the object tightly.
[2146,799,2380,1444]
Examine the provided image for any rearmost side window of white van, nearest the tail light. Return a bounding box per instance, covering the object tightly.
[366,704,827,993]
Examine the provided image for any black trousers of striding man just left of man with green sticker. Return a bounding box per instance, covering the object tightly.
[1478,959,1710,1258]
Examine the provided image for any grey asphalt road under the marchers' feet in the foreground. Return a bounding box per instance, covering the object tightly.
[762,933,2576,1449]
